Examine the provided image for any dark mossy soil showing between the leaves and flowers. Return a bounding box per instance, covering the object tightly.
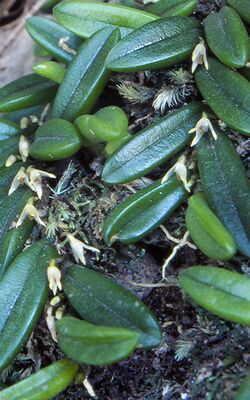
[2,0,250,400]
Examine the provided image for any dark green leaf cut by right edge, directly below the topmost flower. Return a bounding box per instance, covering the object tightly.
[195,58,250,136]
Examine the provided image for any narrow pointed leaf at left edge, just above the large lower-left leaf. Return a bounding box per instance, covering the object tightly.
[0,220,34,278]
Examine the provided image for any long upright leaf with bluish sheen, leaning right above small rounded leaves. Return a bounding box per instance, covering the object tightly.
[52,28,119,121]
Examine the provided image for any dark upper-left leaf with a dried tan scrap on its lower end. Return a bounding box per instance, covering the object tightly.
[26,17,82,64]
